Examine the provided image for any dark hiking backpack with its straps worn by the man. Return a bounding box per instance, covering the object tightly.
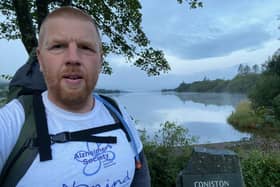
[0,50,141,187]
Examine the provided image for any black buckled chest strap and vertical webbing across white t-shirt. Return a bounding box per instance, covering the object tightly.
[31,94,121,161]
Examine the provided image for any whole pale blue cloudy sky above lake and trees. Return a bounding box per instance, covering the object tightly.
[0,0,280,91]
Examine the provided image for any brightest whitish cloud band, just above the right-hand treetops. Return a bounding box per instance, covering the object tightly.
[166,40,280,75]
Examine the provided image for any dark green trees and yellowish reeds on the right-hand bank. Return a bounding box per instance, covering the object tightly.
[228,49,280,130]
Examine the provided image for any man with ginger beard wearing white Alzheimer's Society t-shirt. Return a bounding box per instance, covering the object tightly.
[0,7,150,187]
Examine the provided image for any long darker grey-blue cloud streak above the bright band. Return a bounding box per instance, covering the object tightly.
[172,25,270,59]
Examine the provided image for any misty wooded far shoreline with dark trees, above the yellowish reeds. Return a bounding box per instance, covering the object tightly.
[165,49,280,127]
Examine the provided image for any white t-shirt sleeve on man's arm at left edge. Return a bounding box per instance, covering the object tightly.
[0,99,25,171]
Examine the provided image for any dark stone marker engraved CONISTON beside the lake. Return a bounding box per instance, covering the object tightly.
[176,147,244,187]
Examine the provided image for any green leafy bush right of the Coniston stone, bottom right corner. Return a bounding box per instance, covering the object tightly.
[241,151,280,187]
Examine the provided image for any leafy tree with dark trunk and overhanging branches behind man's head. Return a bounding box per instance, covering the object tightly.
[0,0,202,75]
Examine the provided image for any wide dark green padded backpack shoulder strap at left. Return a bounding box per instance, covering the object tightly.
[0,95,38,187]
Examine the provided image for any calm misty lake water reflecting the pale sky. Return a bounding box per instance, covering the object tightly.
[104,92,250,143]
